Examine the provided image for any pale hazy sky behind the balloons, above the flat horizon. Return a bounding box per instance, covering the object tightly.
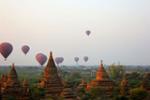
[0,0,150,65]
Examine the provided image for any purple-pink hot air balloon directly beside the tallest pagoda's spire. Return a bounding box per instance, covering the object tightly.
[35,53,47,66]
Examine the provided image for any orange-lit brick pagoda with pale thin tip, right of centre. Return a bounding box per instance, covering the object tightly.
[87,61,113,95]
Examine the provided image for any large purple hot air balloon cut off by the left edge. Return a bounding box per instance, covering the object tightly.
[0,42,13,60]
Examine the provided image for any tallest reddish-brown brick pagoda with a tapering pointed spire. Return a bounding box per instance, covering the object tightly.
[39,52,63,100]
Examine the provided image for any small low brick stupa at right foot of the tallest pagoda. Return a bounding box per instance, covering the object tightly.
[61,82,77,100]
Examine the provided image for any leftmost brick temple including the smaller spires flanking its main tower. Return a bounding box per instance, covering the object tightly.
[0,64,30,100]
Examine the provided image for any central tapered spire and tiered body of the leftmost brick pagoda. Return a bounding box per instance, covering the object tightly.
[1,64,22,100]
